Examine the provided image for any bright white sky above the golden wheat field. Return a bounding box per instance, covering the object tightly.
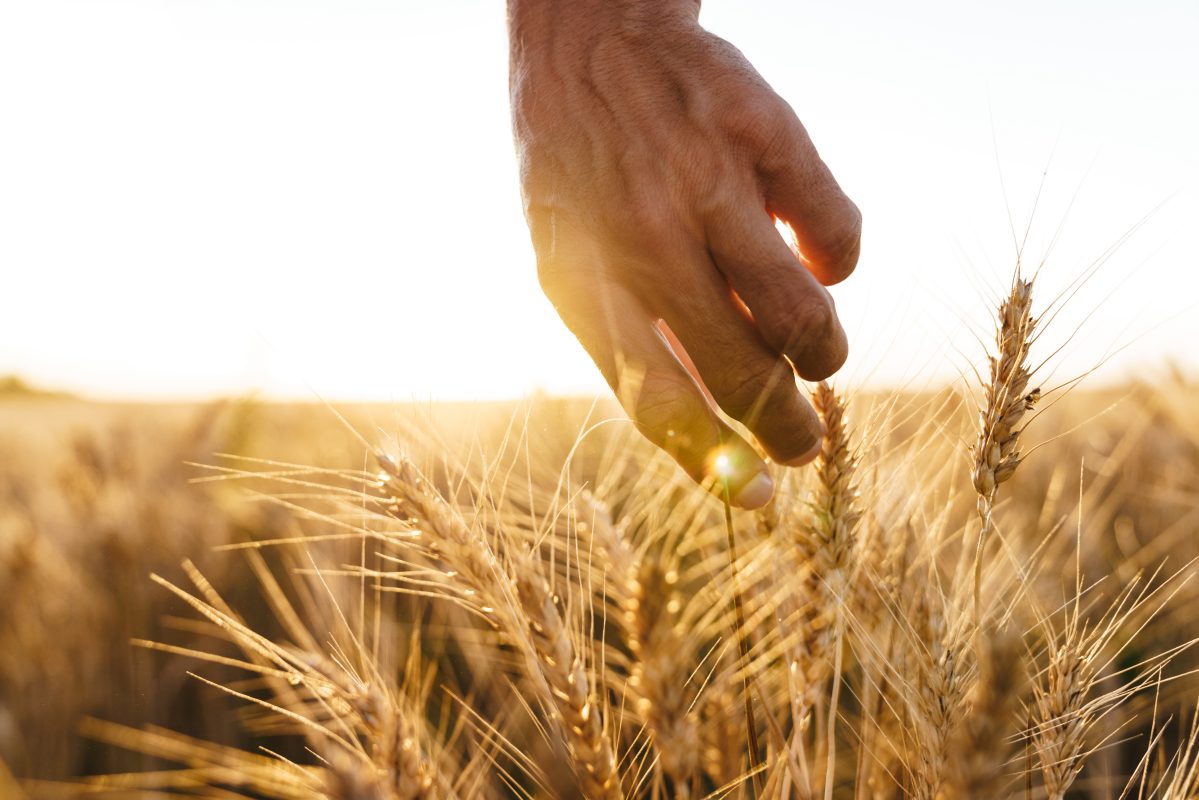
[0,0,1199,399]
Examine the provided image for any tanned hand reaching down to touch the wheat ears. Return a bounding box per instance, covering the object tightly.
[510,0,861,507]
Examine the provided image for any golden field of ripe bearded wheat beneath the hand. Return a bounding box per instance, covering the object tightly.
[0,277,1199,800]
